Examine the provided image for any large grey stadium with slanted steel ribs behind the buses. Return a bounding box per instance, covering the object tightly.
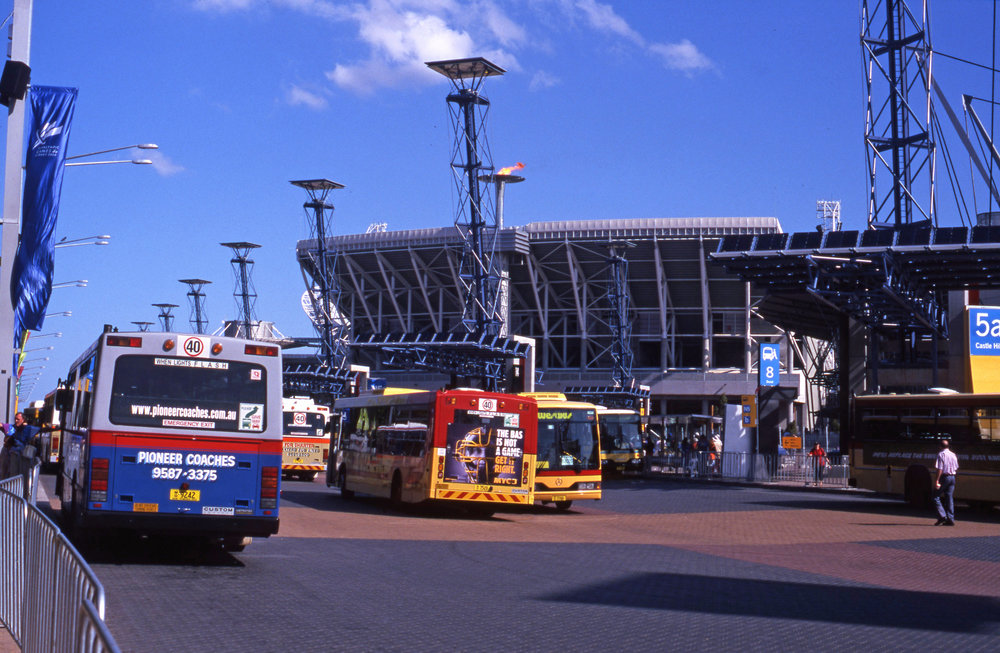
[297,217,817,440]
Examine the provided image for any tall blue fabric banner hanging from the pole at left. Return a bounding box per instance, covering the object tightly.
[10,86,77,346]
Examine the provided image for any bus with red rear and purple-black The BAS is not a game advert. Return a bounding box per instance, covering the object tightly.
[326,389,538,515]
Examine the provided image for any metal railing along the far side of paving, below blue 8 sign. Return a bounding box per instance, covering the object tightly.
[646,451,848,487]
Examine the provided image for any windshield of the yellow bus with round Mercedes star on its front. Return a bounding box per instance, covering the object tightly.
[538,408,601,470]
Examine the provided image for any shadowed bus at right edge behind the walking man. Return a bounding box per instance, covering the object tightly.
[847,393,1000,506]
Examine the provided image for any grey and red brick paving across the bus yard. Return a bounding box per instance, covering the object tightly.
[9,479,1000,652]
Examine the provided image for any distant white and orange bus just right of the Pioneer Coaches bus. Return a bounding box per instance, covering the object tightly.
[281,397,330,481]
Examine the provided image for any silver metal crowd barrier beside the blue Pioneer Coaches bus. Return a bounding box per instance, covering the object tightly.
[0,465,119,653]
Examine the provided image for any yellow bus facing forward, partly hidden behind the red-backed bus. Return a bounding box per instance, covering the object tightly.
[521,392,601,510]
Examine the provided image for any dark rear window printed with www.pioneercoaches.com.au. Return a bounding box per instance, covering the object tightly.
[108,355,267,433]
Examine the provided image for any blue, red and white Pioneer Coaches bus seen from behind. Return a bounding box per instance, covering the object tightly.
[56,327,282,550]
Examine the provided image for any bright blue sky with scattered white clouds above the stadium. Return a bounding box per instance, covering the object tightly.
[4,0,993,399]
